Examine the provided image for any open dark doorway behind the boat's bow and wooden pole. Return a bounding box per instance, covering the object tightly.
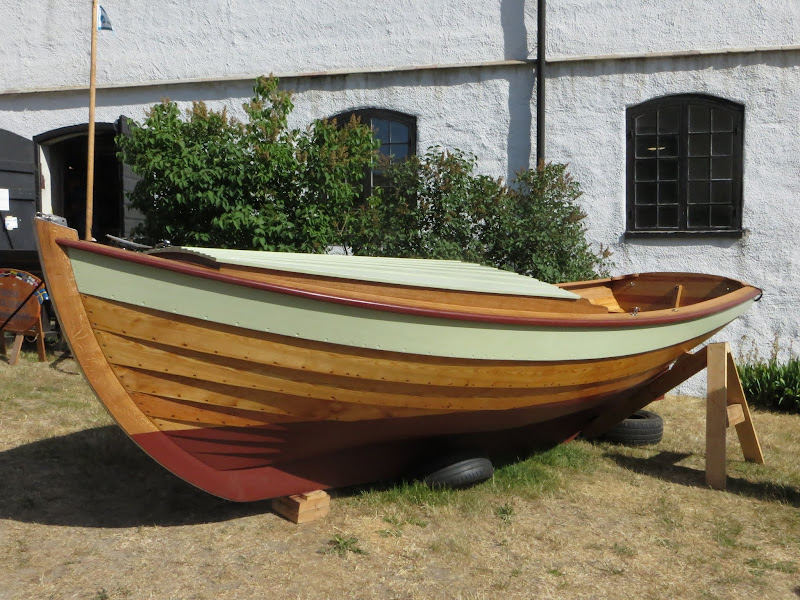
[34,123,124,241]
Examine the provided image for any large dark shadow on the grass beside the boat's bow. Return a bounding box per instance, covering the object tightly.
[0,426,270,528]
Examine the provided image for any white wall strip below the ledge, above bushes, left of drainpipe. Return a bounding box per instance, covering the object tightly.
[0,66,534,177]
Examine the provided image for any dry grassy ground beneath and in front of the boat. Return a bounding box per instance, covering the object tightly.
[0,355,800,600]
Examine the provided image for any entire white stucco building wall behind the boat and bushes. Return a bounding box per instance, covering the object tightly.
[0,0,800,391]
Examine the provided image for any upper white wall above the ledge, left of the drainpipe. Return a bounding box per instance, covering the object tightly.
[0,0,527,92]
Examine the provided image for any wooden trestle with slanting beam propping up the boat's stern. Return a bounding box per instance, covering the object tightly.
[583,342,764,490]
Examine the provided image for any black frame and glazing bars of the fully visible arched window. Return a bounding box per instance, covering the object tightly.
[625,94,744,237]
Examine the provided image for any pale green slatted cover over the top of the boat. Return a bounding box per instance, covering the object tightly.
[159,248,580,300]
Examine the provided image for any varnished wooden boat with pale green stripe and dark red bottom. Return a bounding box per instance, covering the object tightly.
[36,219,761,501]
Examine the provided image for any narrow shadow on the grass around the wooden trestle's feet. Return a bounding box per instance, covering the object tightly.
[604,451,800,508]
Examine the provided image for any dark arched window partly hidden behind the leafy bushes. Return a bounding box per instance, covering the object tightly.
[333,108,417,197]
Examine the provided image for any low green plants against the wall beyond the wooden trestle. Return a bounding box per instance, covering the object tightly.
[738,357,800,413]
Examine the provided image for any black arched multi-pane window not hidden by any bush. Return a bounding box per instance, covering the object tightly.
[626,94,744,235]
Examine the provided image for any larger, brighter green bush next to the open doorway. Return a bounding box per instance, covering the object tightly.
[117,77,376,252]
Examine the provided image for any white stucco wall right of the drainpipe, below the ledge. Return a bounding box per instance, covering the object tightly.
[547,51,800,393]
